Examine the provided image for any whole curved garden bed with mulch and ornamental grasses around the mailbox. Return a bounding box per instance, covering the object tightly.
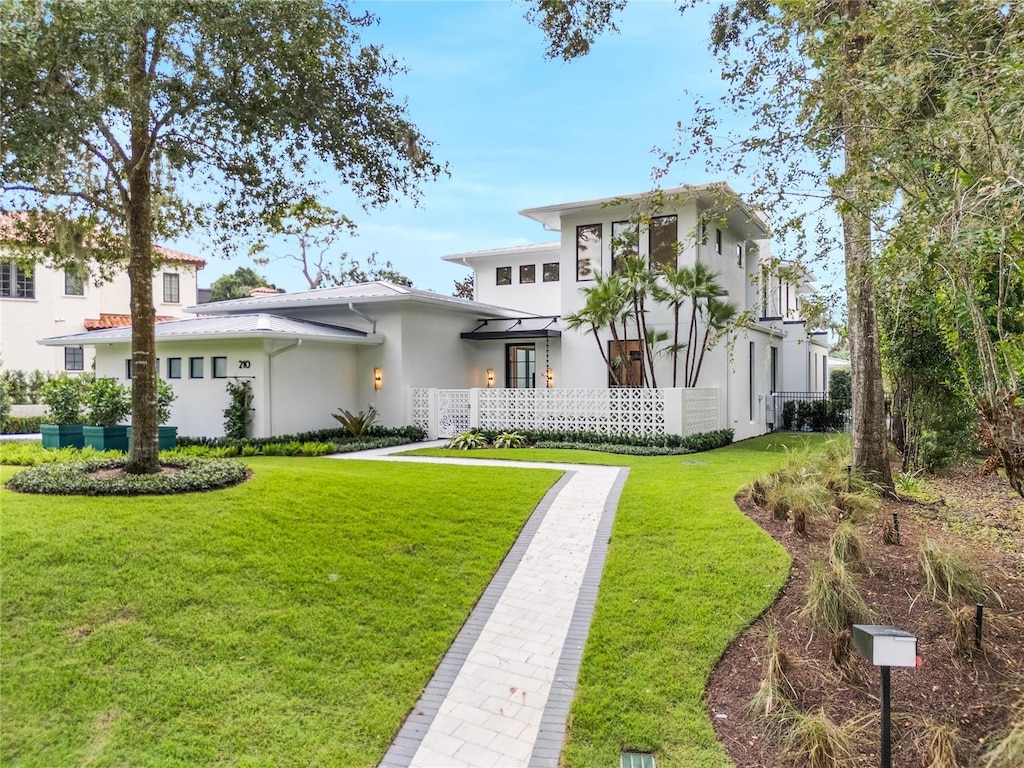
[707,456,1024,768]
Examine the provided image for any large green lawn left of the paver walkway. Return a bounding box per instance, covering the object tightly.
[0,459,558,768]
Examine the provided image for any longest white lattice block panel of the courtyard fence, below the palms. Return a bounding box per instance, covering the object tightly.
[475,388,667,434]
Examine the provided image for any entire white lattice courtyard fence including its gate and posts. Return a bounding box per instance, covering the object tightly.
[409,387,724,437]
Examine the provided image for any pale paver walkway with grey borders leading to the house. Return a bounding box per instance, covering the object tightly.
[335,443,629,768]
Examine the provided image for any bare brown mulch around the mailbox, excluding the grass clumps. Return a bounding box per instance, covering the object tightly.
[708,469,1024,768]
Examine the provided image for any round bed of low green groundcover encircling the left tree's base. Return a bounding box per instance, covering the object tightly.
[7,457,249,496]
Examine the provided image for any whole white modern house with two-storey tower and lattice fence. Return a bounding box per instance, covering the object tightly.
[40,184,827,439]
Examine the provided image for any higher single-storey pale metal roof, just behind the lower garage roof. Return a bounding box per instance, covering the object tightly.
[185,281,536,317]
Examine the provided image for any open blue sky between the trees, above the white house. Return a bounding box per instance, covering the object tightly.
[169,0,761,294]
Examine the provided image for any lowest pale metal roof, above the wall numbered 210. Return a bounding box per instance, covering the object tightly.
[39,314,383,346]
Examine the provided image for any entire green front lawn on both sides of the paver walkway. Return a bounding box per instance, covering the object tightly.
[0,435,813,766]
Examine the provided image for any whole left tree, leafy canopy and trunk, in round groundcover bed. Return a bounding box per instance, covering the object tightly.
[0,0,443,472]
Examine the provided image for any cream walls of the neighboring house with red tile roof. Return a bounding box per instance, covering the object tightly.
[0,241,206,373]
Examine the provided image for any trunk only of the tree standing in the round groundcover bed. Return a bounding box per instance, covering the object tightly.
[125,24,160,474]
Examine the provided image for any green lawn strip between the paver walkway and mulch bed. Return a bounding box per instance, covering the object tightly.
[407,435,822,768]
